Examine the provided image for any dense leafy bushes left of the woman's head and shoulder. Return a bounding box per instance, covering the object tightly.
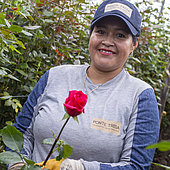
[0,0,95,128]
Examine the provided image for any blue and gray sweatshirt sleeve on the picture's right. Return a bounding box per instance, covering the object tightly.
[82,88,160,170]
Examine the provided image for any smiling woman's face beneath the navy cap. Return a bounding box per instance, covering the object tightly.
[89,16,137,74]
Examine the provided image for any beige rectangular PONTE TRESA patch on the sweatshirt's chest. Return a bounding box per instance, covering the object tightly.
[91,118,121,135]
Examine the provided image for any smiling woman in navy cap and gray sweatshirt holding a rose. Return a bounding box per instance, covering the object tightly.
[8,0,159,170]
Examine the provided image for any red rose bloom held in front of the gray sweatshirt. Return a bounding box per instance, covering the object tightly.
[64,90,87,117]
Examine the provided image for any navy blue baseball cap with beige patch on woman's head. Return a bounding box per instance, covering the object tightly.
[90,0,141,37]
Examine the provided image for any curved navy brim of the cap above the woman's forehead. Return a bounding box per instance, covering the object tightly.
[91,14,138,36]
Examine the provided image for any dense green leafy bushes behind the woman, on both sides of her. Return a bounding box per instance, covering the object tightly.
[0,0,170,169]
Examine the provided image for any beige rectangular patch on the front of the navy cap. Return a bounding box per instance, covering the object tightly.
[104,3,132,18]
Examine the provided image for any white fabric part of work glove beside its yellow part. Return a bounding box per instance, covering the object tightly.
[60,159,84,170]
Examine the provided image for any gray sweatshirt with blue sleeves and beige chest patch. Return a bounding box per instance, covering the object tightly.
[11,65,159,170]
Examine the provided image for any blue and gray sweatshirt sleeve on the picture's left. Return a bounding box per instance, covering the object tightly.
[6,71,49,159]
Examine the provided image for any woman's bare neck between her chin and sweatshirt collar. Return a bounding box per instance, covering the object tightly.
[87,66,122,84]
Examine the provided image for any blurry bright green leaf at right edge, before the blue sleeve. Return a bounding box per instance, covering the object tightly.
[146,141,170,151]
